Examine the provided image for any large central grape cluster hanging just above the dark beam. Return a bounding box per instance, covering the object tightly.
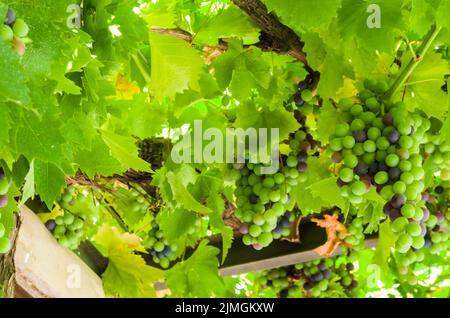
[230,158,299,250]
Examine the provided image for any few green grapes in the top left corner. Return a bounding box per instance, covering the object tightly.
[0,8,29,55]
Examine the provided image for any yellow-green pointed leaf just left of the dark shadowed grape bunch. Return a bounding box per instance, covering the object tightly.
[102,130,152,172]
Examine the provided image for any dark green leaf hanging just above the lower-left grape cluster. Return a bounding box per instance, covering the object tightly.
[34,160,66,208]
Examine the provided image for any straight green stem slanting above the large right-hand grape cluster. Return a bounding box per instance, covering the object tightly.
[384,25,442,99]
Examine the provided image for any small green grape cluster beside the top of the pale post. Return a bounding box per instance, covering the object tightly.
[45,211,85,250]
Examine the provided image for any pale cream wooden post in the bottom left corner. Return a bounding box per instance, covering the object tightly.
[0,207,105,298]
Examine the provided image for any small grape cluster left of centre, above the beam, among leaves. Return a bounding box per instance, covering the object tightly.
[144,220,178,268]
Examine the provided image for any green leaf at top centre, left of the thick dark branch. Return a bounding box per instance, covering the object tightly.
[195,6,259,45]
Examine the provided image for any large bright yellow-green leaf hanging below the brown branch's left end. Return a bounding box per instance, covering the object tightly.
[150,33,203,100]
